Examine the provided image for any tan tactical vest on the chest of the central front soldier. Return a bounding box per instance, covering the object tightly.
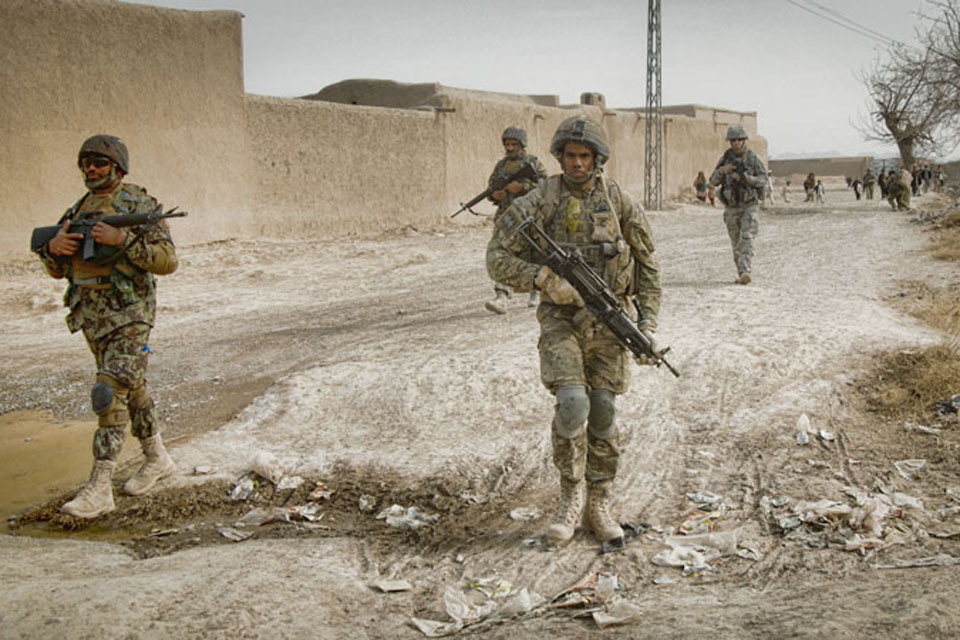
[543,175,633,295]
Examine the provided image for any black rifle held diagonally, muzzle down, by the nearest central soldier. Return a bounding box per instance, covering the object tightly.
[515,217,680,378]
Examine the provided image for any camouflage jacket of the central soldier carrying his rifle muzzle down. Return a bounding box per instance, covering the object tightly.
[487,175,660,330]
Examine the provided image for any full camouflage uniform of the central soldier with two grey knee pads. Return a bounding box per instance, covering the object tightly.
[487,119,660,540]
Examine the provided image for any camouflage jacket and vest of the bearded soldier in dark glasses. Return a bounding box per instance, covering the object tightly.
[38,183,178,340]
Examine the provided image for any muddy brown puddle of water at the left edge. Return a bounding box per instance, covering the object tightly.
[0,411,140,531]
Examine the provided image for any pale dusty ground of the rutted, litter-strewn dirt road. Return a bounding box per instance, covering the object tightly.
[0,186,960,638]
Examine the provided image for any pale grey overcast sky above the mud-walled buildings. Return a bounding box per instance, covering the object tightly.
[131,0,922,158]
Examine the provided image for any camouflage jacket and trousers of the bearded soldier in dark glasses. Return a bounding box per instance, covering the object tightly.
[39,183,177,461]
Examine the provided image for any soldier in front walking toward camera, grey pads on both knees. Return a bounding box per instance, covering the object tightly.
[487,116,660,543]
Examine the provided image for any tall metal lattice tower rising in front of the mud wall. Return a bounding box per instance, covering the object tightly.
[643,0,663,210]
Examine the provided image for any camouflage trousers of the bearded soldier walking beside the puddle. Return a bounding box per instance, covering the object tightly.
[85,322,159,461]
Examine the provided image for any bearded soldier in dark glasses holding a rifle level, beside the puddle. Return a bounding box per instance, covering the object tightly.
[33,135,177,518]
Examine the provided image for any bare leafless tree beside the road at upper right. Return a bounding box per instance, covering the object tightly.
[858,44,957,168]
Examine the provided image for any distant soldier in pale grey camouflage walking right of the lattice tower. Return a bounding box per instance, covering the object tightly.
[710,124,767,284]
